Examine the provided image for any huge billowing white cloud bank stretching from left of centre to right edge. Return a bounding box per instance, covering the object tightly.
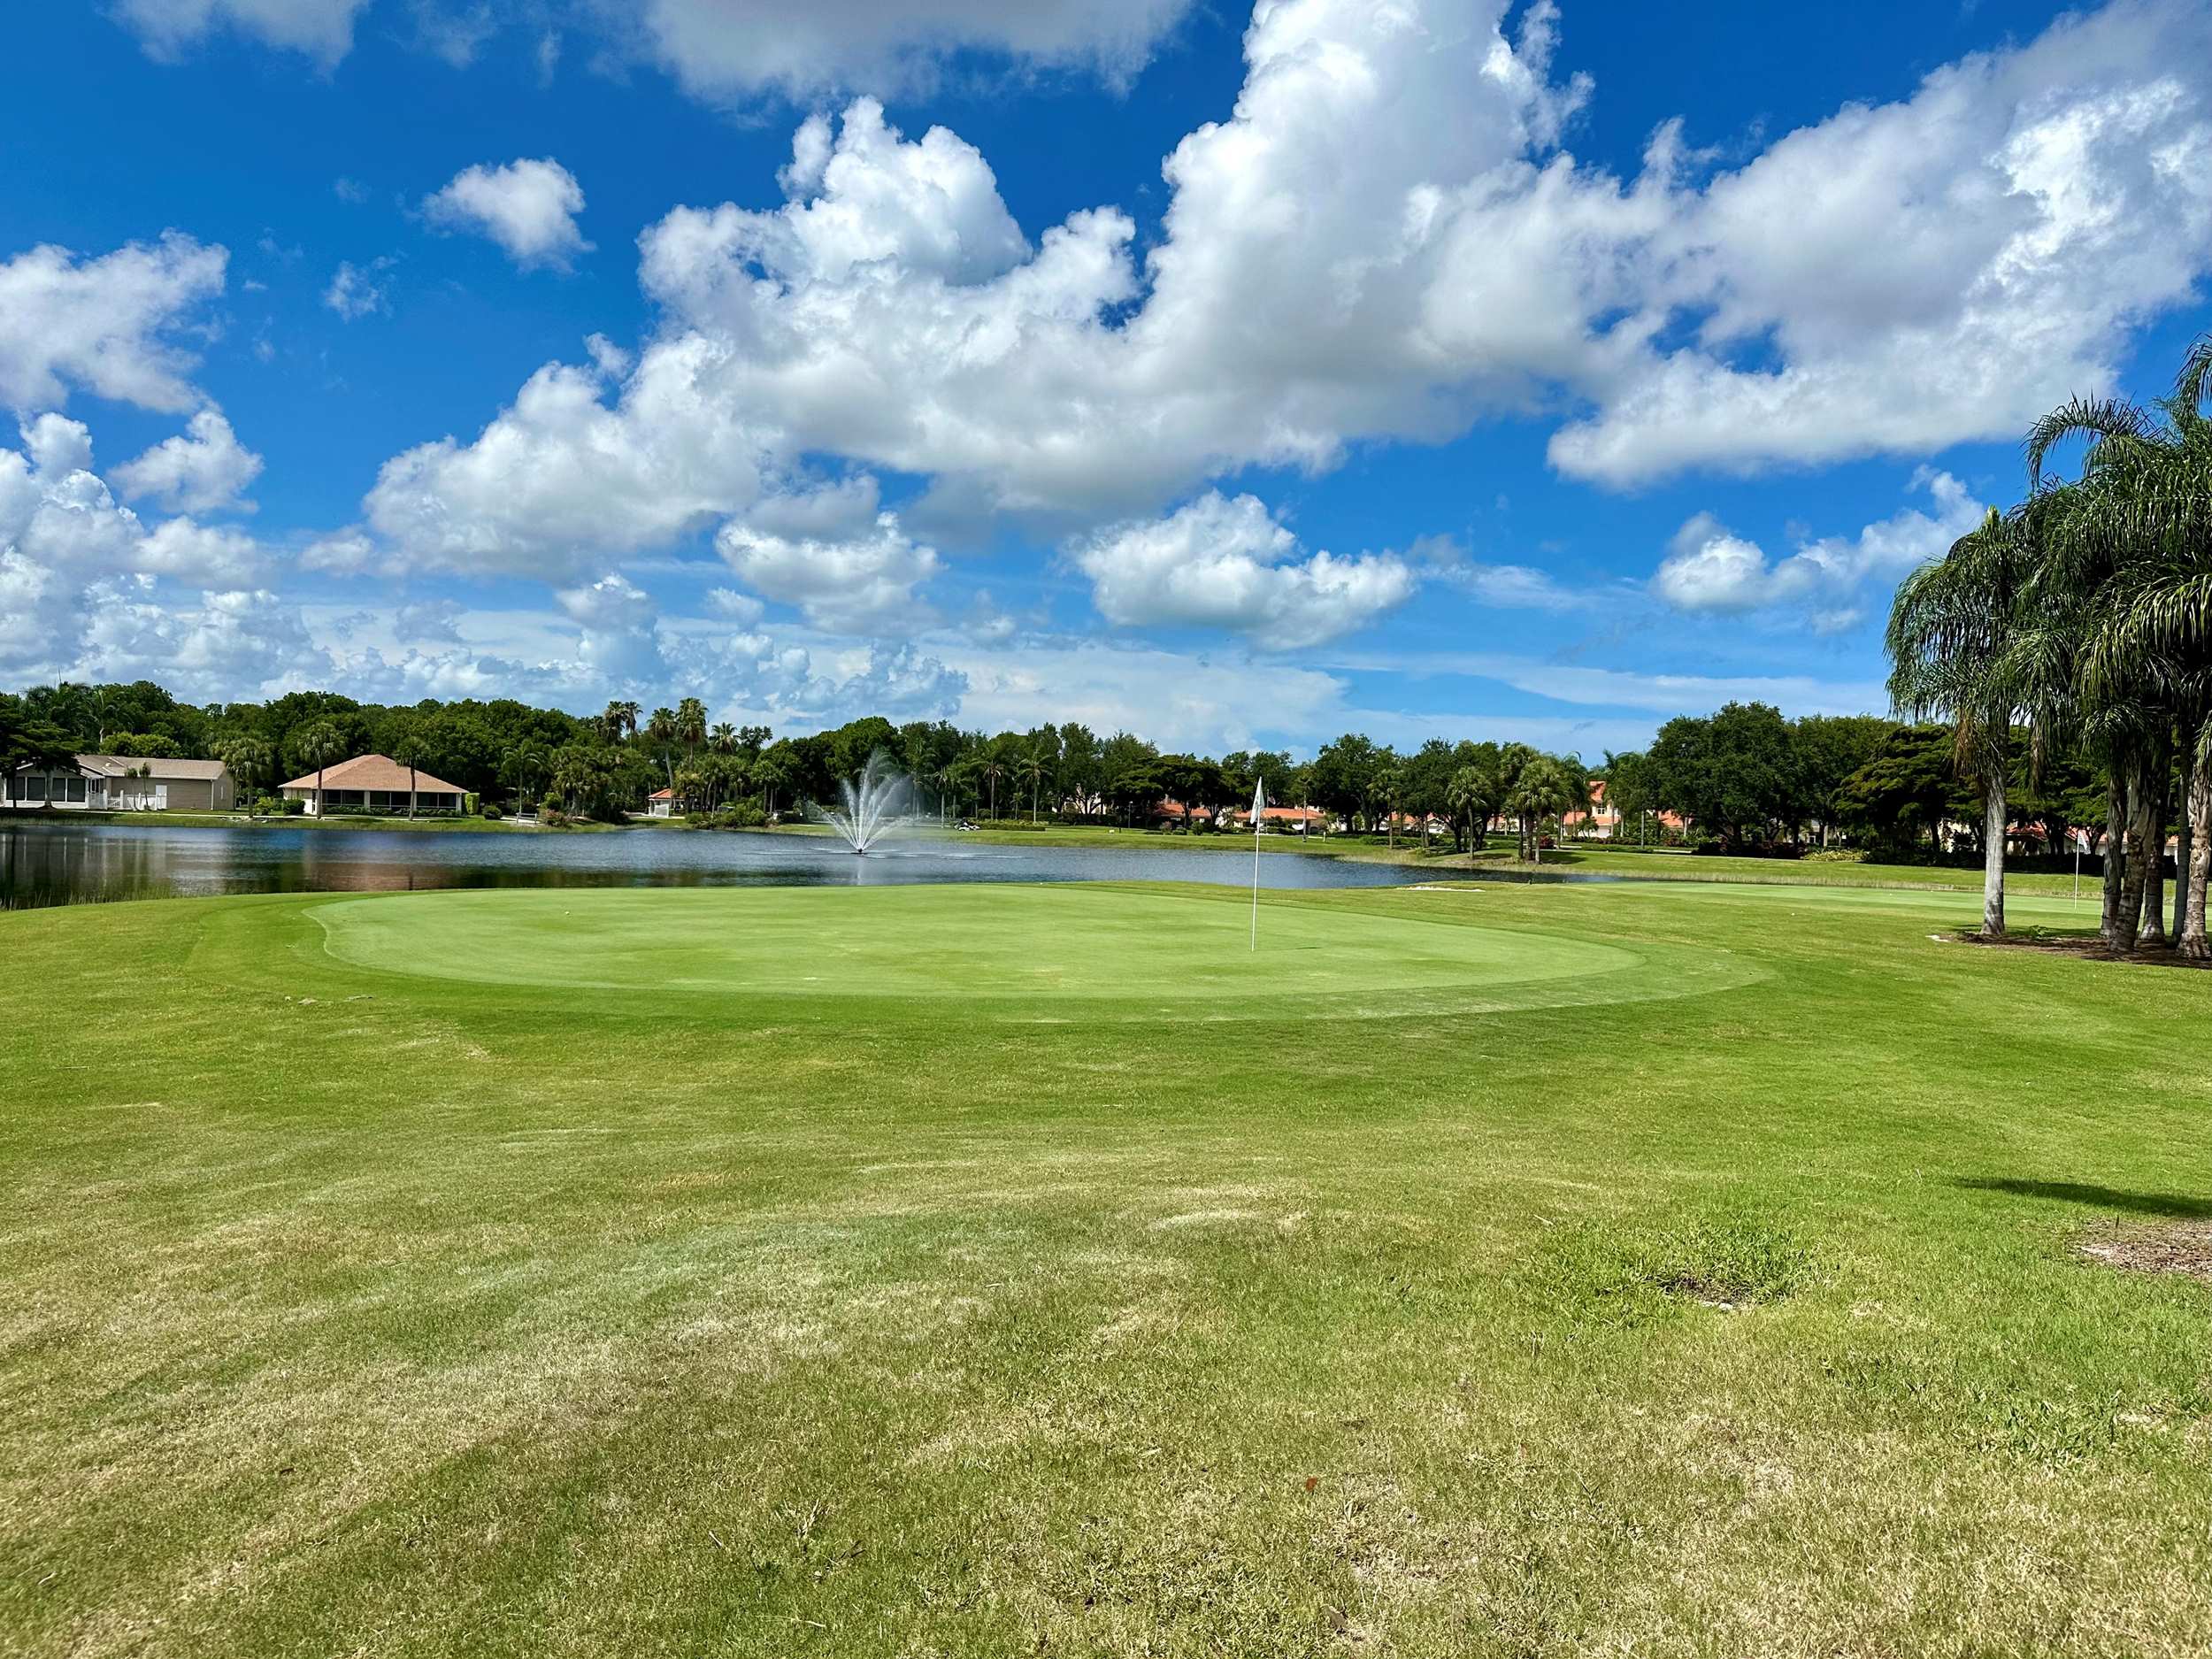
[370,0,2212,593]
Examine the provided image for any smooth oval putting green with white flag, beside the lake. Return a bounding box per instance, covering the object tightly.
[314,885,1743,1018]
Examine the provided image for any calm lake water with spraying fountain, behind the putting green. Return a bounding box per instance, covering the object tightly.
[0,823,1469,910]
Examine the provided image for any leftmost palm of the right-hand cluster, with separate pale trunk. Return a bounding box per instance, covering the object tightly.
[1889,509,2035,938]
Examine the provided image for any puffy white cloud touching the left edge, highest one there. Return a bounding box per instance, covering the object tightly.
[0,233,230,414]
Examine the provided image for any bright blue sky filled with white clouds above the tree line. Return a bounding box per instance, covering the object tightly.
[0,0,2212,759]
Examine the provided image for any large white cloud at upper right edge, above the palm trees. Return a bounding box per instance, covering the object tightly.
[1553,0,2212,482]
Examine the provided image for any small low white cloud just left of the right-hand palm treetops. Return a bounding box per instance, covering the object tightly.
[1653,473,1985,633]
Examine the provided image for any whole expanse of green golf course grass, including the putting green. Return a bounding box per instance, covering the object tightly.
[0,885,2212,1657]
